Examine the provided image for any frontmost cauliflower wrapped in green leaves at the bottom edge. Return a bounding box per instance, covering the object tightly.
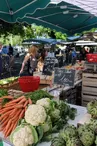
[10,125,38,146]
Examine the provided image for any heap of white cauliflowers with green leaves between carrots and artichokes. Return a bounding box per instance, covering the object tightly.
[5,97,76,146]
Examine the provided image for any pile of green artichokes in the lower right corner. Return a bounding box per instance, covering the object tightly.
[51,100,97,146]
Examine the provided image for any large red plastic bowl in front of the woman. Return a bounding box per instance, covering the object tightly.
[18,76,40,92]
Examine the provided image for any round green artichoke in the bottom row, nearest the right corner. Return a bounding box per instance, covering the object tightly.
[78,124,95,146]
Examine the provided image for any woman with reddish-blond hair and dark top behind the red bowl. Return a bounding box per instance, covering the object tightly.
[20,46,37,76]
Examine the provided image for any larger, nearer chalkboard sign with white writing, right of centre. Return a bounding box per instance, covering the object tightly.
[54,68,75,87]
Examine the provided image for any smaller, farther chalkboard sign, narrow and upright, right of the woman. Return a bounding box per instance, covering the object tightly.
[43,57,55,76]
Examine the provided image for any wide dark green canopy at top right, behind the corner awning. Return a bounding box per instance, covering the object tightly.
[18,0,97,35]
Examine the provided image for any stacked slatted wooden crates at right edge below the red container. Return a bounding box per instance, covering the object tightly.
[82,73,97,106]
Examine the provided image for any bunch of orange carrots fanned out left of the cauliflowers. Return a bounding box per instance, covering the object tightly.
[0,96,32,137]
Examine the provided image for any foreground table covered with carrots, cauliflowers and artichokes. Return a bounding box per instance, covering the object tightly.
[0,86,97,146]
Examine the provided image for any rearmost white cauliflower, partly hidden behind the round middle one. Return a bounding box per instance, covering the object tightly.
[36,98,50,108]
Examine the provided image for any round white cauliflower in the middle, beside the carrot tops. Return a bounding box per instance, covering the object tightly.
[25,104,47,126]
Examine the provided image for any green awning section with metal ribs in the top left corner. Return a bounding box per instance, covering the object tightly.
[0,0,50,23]
